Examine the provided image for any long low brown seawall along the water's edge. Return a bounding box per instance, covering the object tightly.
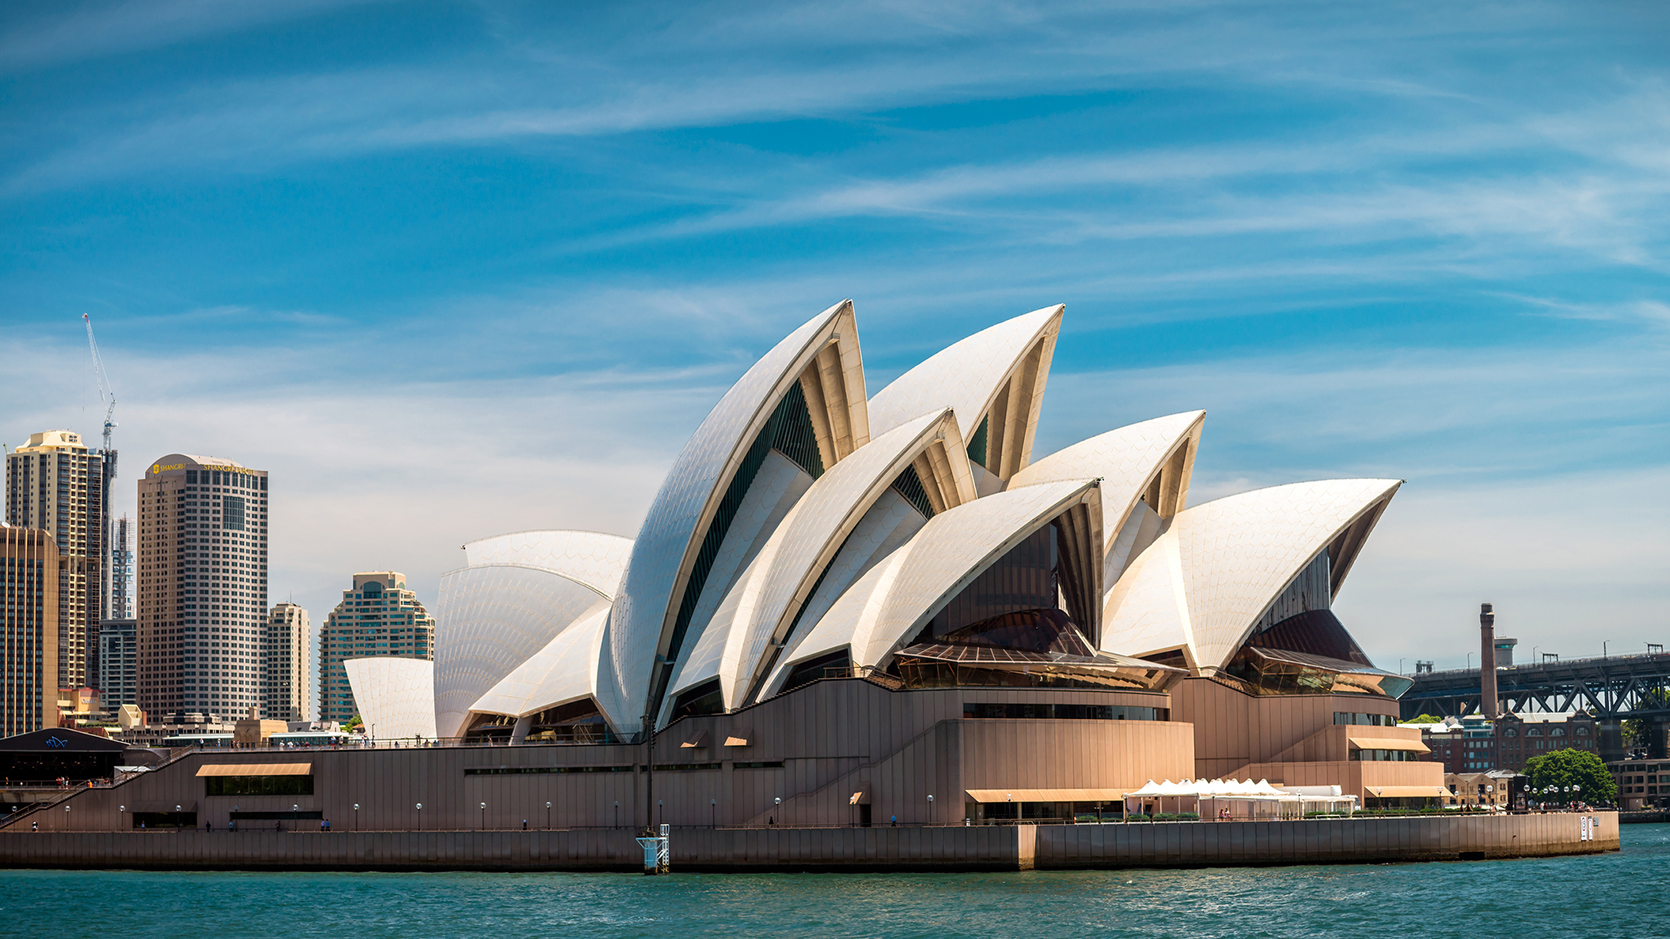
[0,812,1618,872]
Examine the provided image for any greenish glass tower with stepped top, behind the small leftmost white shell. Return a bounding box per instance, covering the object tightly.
[319,571,434,720]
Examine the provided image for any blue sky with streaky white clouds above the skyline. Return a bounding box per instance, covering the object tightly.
[0,0,1670,685]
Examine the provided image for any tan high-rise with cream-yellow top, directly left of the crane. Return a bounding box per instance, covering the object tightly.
[5,431,104,688]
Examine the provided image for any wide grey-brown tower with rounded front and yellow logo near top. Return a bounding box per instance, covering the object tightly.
[134,453,267,720]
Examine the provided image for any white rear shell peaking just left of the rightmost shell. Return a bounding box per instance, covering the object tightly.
[1009,411,1206,590]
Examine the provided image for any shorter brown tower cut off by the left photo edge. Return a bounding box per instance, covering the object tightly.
[0,528,63,737]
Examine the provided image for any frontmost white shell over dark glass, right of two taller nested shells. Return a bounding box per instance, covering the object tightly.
[765,480,1101,693]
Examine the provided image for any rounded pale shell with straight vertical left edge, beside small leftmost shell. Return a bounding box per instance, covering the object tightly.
[434,565,610,737]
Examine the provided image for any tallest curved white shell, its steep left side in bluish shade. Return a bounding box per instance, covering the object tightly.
[606,301,870,732]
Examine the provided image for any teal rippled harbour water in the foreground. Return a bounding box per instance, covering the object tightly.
[0,825,1670,939]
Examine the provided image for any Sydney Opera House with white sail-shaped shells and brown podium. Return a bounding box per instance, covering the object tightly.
[303,302,1443,825]
